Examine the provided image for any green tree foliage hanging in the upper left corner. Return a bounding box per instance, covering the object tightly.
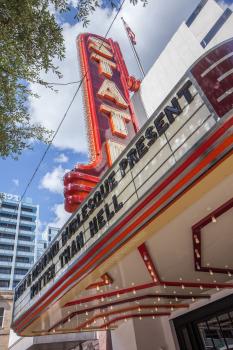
[0,0,147,158]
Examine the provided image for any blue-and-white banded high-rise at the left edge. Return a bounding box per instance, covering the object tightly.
[0,193,39,289]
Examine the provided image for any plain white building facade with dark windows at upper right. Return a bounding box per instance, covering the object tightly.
[133,0,233,125]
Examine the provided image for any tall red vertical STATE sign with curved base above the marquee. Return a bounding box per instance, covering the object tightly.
[64,34,140,212]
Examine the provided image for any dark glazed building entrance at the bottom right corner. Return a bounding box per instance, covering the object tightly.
[174,296,233,350]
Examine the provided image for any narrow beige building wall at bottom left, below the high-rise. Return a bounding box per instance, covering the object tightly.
[0,291,14,350]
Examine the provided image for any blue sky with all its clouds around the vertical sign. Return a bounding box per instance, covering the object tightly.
[0,0,233,237]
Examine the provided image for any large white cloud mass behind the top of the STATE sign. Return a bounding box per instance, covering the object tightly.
[29,0,199,153]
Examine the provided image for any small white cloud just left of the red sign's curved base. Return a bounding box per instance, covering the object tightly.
[40,165,69,194]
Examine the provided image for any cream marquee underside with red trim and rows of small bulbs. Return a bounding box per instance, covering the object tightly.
[16,146,233,335]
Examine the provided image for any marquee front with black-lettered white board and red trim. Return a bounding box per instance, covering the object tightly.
[13,41,233,333]
